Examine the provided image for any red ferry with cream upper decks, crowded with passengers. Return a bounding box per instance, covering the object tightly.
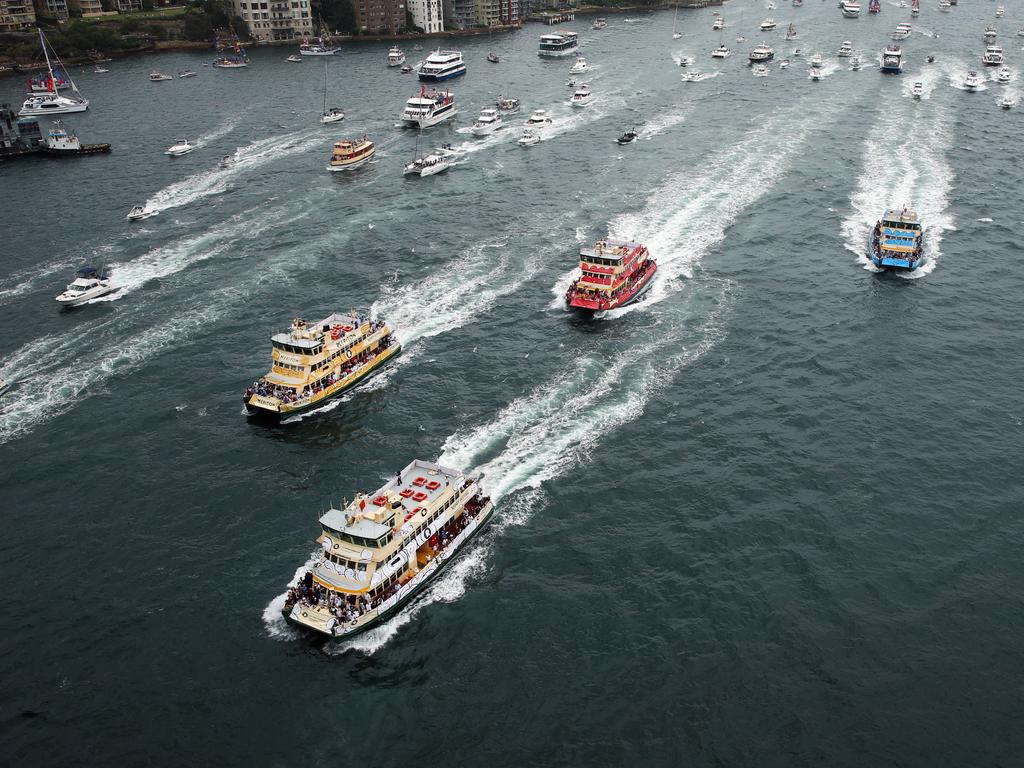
[565,240,657,312]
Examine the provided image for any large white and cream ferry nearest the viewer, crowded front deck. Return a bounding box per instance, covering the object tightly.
[282,459,494,642]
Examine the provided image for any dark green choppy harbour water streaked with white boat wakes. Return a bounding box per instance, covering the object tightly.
[0,2,1024,766]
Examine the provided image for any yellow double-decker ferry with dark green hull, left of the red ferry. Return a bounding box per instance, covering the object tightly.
[242,312,401,420]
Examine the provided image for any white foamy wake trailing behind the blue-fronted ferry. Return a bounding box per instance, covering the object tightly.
[842,98,954,278]
